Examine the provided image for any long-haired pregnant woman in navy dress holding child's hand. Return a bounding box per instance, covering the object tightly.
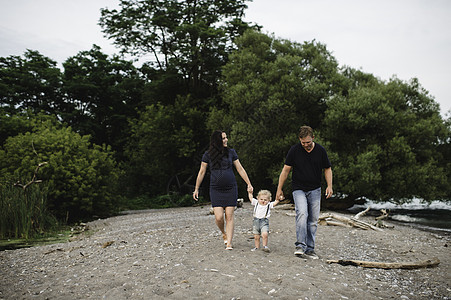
[193,130,254,250]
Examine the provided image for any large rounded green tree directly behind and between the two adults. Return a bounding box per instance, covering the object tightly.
[208,31,341,190]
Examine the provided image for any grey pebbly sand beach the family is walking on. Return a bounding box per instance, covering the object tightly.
[0,202,451,300]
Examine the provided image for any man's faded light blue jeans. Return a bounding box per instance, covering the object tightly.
[293,188,321,252]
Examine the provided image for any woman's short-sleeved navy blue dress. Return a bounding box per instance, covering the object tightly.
[202,148,238,207]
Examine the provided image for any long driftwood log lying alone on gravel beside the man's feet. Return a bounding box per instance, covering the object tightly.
[327,258,440,269]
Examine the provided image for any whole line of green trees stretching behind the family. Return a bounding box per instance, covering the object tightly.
[0,0,451,239]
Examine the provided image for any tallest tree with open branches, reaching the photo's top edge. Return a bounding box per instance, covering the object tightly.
[99,0,256,100]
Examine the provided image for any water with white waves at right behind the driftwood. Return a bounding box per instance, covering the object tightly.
[349,199,451,235]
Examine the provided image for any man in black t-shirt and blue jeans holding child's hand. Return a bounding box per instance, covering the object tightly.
[276,126,333,259]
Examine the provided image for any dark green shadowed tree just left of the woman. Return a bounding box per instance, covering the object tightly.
[124,96,204,196]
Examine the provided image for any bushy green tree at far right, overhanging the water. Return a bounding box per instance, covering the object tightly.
[322,70,449,203]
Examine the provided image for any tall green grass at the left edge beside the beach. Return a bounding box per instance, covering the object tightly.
[0,184,58,239]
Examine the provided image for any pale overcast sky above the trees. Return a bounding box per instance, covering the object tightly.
[0,0,451,116]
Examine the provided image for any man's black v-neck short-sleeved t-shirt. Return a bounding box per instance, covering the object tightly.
[285,143,331,192]
